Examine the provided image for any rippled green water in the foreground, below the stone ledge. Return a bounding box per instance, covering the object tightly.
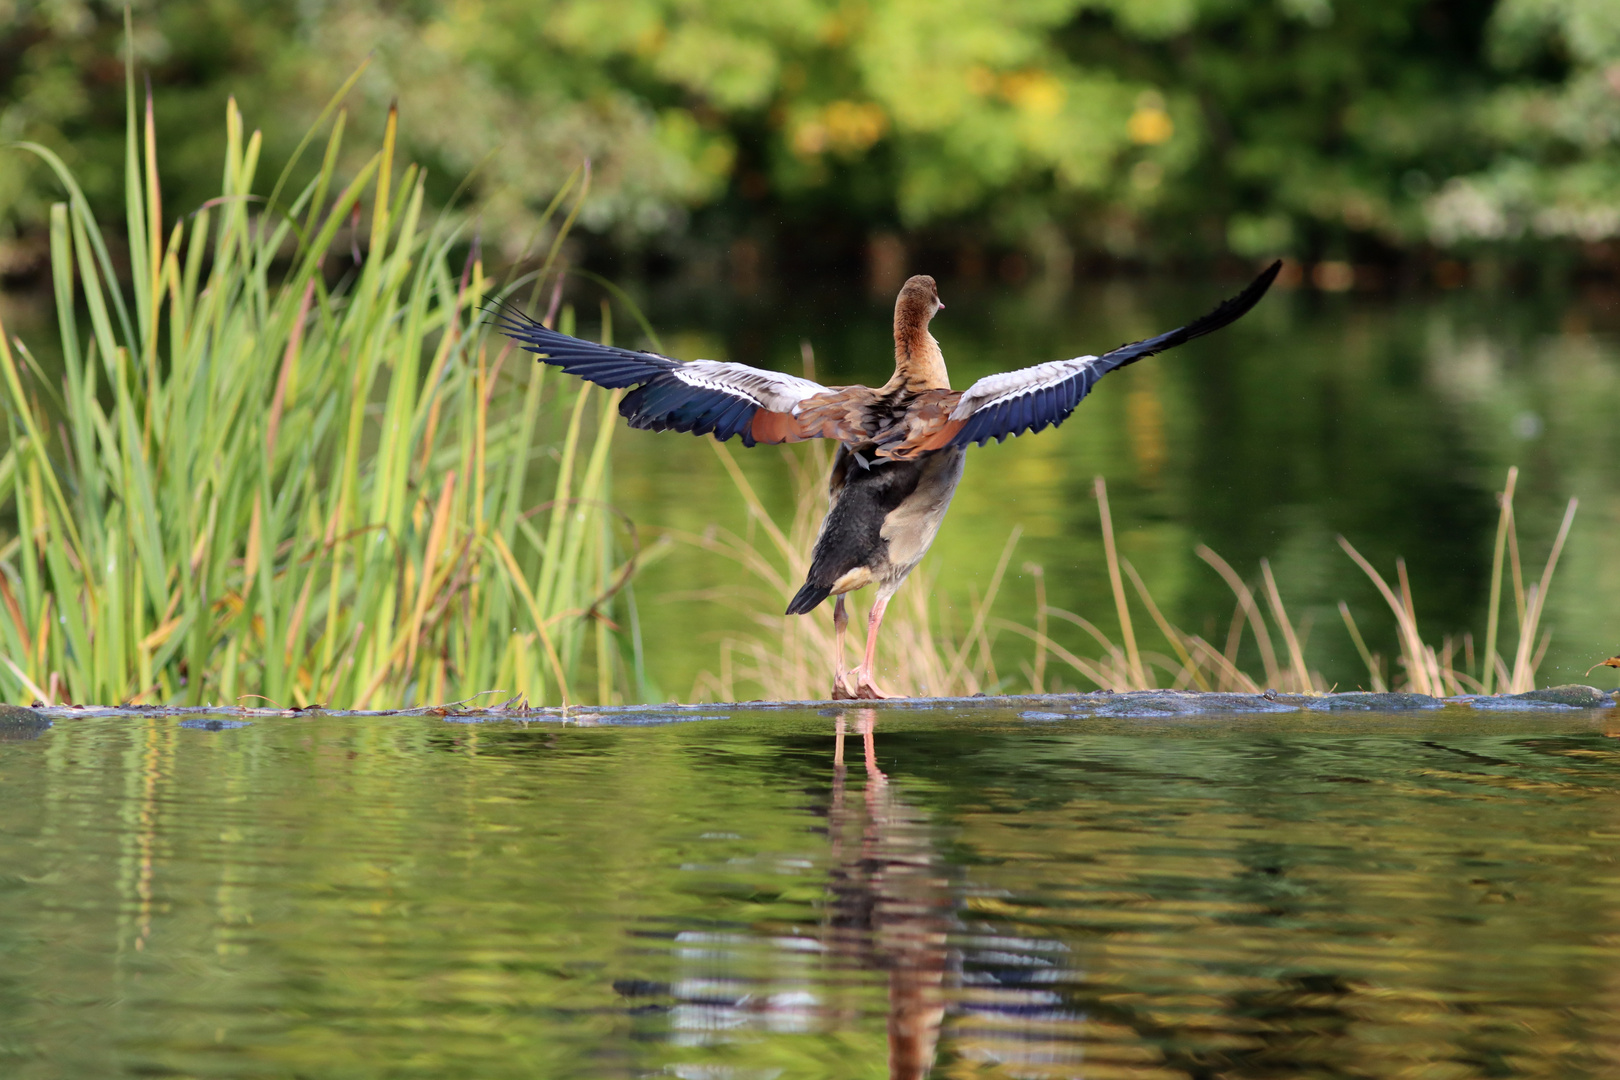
[0,711,1620,1080]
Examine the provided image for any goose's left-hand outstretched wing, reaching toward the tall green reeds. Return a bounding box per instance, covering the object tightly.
[496,306,831,447]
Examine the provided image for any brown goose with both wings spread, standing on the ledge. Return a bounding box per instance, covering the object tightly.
[496,261,1283,699]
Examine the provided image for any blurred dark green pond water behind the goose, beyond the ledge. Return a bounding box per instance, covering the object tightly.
[622,282,1620,699]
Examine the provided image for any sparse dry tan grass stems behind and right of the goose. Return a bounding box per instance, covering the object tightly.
[693,444,1578,701]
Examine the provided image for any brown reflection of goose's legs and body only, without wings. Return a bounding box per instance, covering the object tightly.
[826,709,954,1080]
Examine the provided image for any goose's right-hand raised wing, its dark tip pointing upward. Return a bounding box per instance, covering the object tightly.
[930,261,1283,447]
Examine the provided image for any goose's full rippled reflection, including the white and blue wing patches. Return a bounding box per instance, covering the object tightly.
[616,709,1084,1080]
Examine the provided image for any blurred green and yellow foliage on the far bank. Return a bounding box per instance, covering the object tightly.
[0,0,1620,259]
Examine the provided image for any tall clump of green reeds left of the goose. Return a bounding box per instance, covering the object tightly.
[0,52,632,708]
